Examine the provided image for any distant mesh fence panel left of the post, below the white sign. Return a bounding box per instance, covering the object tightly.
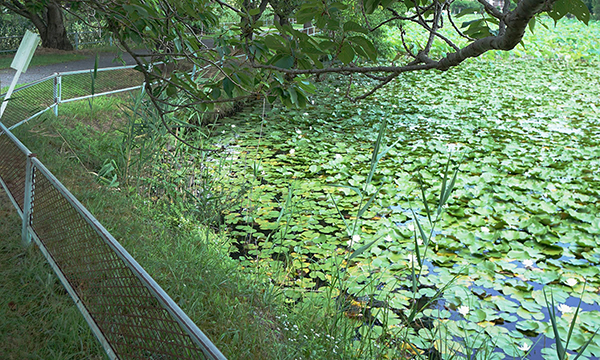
[1,77,55,128]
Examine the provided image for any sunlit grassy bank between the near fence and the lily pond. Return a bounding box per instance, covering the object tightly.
[0,96,346,359]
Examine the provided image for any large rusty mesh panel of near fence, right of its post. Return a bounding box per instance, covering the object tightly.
[31,167,213,359]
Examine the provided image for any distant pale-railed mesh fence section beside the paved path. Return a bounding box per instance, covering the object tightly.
[0,65,144,130]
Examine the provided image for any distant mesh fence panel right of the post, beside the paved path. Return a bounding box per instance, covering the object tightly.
[60,67,144,101]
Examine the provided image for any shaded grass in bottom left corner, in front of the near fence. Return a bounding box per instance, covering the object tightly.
[0,190,105,360]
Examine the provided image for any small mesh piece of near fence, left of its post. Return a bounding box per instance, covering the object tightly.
[0,130,27,211]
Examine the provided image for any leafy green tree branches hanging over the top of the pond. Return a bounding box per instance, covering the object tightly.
[93,0,590,135]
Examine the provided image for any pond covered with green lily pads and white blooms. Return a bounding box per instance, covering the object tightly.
[210,59,600,359]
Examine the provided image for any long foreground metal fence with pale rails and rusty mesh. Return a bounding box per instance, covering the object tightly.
[0,75,225,360]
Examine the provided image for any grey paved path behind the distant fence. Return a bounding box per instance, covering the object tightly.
[0,53,143,87]
